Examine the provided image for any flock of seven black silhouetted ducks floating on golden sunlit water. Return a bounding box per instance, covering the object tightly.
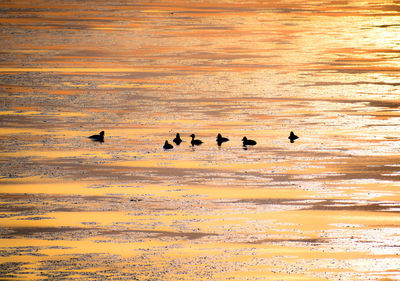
[89,131,299,150]
